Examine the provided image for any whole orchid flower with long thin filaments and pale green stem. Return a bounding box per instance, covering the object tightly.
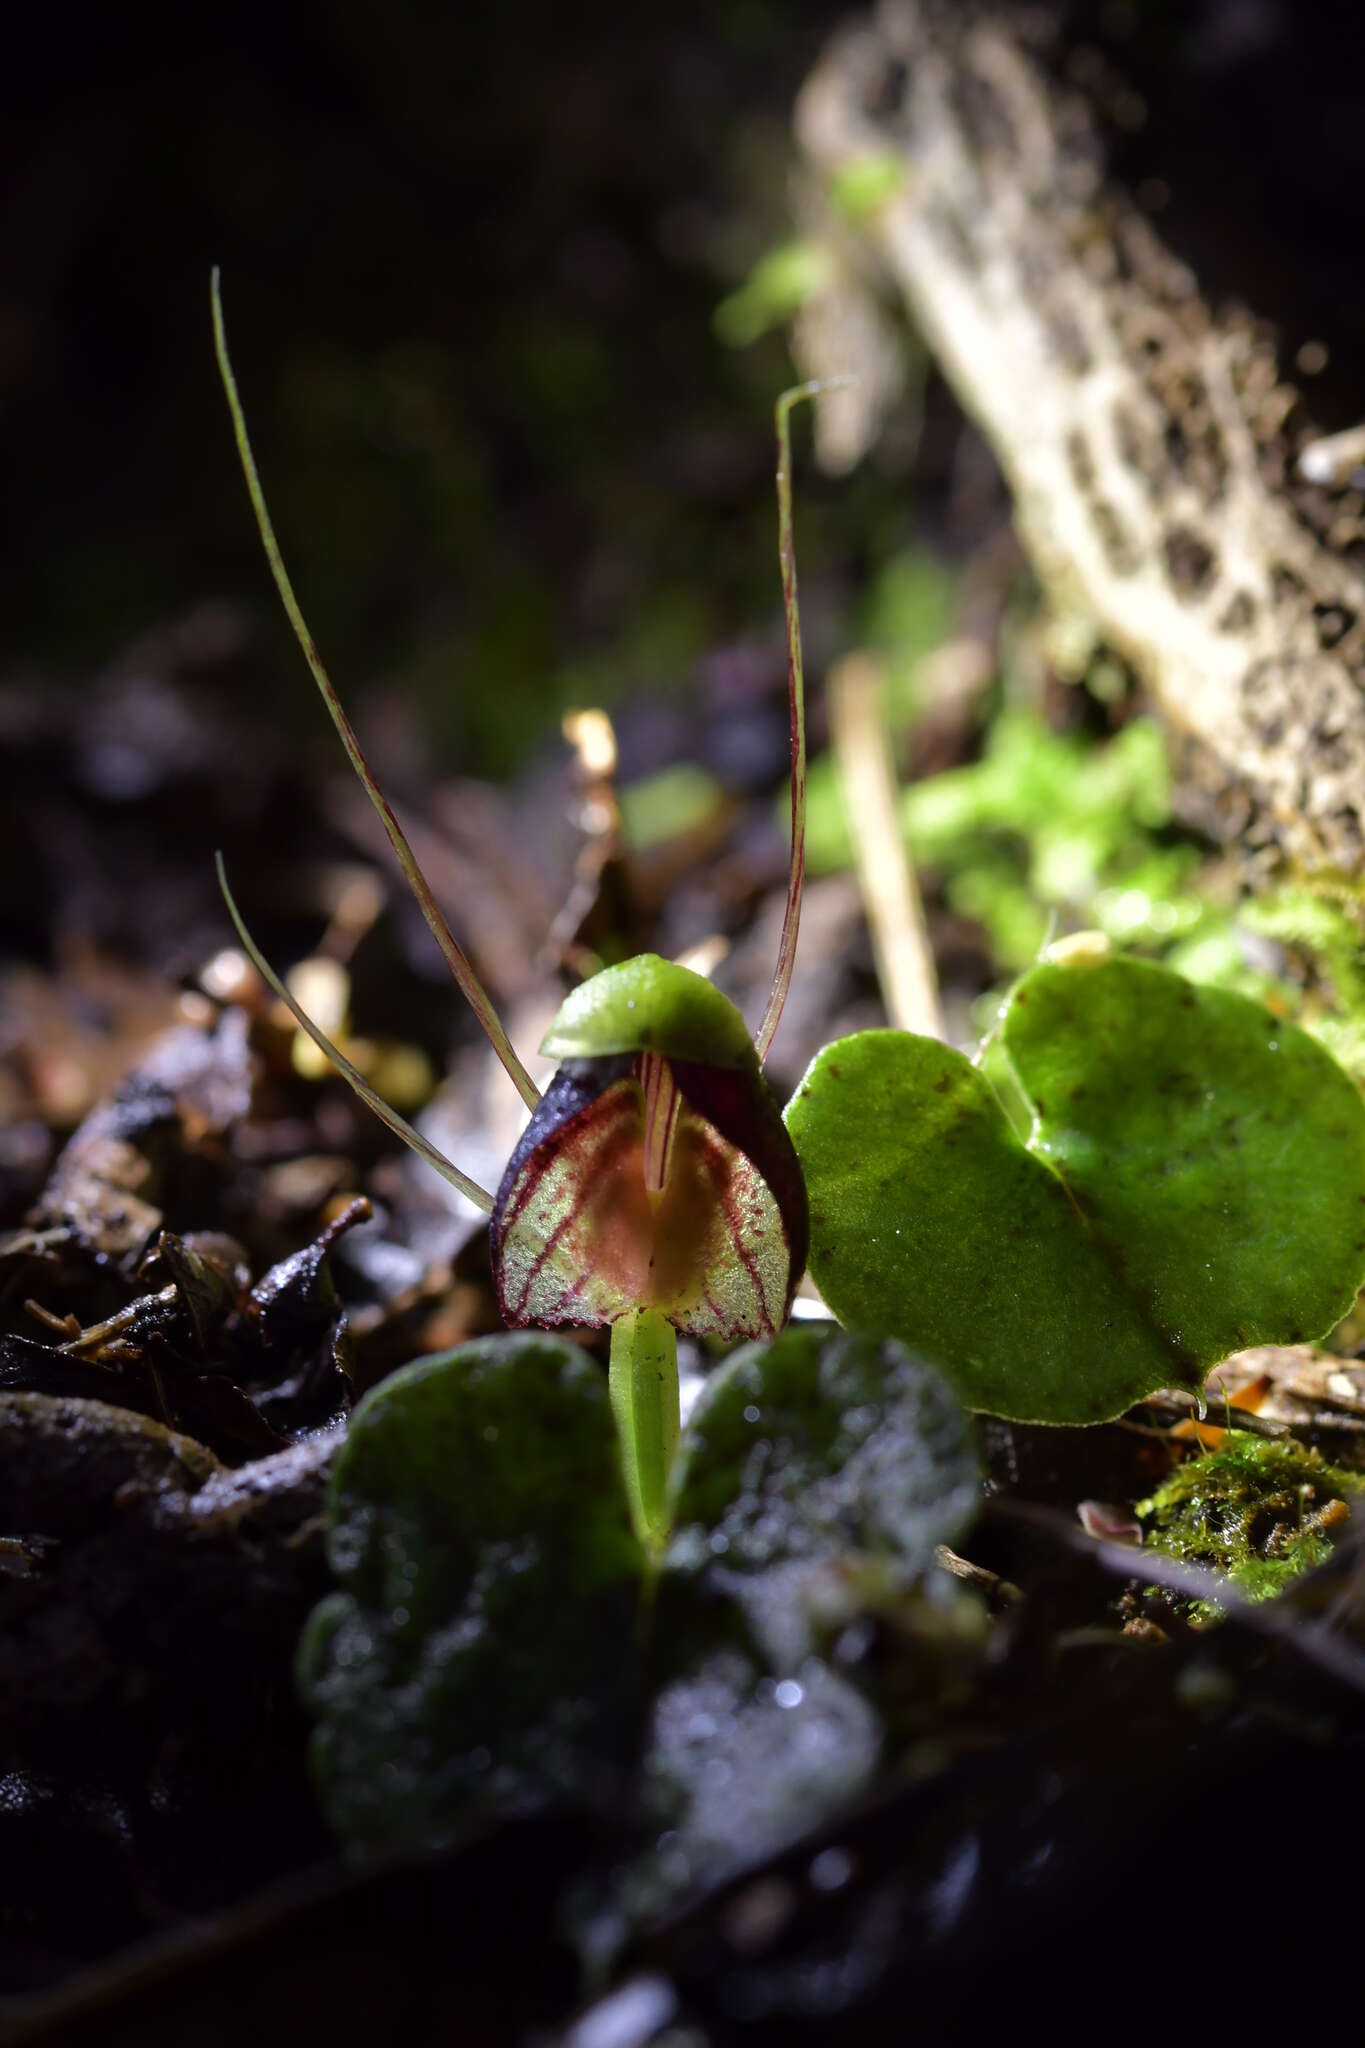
[213,270,829,1544]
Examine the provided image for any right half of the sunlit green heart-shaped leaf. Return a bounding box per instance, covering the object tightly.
[1003,954,1365,1376]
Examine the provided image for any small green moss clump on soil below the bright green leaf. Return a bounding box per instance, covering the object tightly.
[1138,1432,1365,1620]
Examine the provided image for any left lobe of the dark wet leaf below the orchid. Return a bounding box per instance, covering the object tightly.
[299,1335,643,1845]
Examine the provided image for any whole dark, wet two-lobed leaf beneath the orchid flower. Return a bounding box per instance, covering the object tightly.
[301,1325,976,1875]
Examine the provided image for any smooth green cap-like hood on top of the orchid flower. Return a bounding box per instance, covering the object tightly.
[540,952,757,1067]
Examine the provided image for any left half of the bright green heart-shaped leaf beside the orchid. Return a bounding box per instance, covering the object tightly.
[786,1030,1193,1421]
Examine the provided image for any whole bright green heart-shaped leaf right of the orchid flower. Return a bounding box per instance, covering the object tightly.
[788,958,1365,1421]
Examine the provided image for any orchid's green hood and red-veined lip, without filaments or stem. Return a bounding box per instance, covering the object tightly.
[491,954,808,1341]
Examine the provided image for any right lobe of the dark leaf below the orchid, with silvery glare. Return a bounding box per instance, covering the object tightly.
[645,1323,980,1894]
